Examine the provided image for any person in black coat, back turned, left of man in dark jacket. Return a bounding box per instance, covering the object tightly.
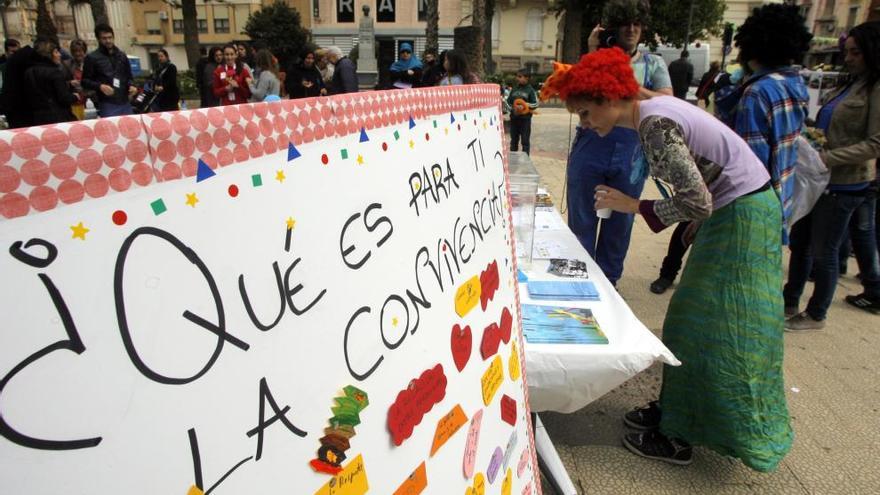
[24,40,76,125]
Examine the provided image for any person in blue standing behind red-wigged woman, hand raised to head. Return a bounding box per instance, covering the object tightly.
[567,0,672,285]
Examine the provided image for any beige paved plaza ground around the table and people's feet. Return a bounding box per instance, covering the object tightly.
[532,108,880,495]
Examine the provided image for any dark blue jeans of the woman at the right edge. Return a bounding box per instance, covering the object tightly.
[783,190,880,320]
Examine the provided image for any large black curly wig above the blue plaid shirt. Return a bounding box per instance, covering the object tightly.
[734,3,813,67]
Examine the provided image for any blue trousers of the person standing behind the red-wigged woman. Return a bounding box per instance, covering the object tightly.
[567,127,645,284]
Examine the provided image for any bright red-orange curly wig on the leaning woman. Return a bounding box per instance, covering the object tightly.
[541,47,639,101]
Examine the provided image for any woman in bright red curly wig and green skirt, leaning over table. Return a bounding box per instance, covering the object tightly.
[542,48,793,471]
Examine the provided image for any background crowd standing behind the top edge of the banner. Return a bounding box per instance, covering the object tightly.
[0,24,484,128]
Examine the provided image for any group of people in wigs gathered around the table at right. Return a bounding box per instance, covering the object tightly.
[544,0,880,471]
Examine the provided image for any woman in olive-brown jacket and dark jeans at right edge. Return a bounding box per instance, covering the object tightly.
[784,22,880,332]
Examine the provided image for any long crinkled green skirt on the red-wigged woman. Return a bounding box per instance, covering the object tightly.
[660,190,794,471]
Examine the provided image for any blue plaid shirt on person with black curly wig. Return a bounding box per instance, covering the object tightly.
[733,68,809,244]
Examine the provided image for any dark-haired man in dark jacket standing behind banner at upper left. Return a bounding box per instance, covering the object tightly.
[82,24,137,117]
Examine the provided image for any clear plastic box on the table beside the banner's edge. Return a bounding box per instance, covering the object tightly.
[508,151,540,270]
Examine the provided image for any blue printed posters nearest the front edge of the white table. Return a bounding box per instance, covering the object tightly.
[522,304,608,344]
